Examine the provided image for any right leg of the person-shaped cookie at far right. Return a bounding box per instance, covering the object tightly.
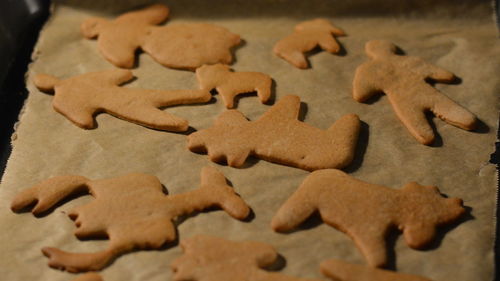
[431,91,476,130]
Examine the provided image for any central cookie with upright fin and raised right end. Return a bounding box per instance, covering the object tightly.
[188,96,360,171]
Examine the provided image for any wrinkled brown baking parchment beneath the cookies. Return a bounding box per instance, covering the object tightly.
[0,0,500,281]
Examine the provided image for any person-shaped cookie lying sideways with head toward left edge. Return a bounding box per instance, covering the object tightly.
[34,69,212,132]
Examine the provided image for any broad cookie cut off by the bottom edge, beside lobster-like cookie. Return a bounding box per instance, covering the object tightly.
[171,235,319,281]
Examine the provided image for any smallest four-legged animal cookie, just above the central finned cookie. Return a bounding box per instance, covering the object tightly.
[196,64,272,108]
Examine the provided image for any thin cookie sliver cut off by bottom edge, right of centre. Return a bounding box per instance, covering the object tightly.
[320,259,431,281]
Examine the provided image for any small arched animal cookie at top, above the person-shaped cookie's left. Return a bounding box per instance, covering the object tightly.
[273,19,345,69]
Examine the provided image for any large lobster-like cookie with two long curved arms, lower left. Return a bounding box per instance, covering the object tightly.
[11,167,250,272]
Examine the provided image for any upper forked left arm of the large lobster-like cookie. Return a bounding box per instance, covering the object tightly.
[11,176,89,215]
